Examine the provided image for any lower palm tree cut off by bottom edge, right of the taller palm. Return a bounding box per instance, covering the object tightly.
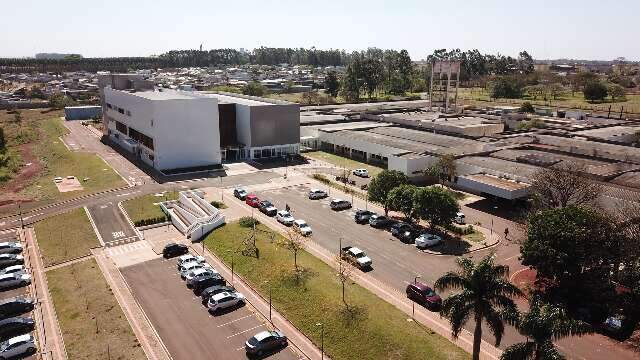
[500,296,593,360]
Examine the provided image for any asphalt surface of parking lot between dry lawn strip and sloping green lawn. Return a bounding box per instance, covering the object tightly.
[121,258,299,359]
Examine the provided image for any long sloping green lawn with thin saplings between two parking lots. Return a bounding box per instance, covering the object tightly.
[205,222,470,360]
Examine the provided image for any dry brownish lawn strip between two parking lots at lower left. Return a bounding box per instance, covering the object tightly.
[47,259,146,360]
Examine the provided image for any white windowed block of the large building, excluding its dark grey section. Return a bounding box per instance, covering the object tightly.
[104,87,221,171]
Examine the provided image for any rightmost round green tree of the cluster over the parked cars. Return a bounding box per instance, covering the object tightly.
[414,186,460,228]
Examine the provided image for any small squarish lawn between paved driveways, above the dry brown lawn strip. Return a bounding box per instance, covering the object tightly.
[35,208,100,266]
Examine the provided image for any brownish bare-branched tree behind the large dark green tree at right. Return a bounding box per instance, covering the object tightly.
[531,163,602,209]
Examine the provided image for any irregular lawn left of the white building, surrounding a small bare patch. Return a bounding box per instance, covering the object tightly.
[25,118,126,200]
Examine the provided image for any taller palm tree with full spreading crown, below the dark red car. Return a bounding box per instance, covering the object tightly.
[434,254,523,360]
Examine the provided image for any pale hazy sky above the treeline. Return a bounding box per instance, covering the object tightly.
[0,0,640,60]
